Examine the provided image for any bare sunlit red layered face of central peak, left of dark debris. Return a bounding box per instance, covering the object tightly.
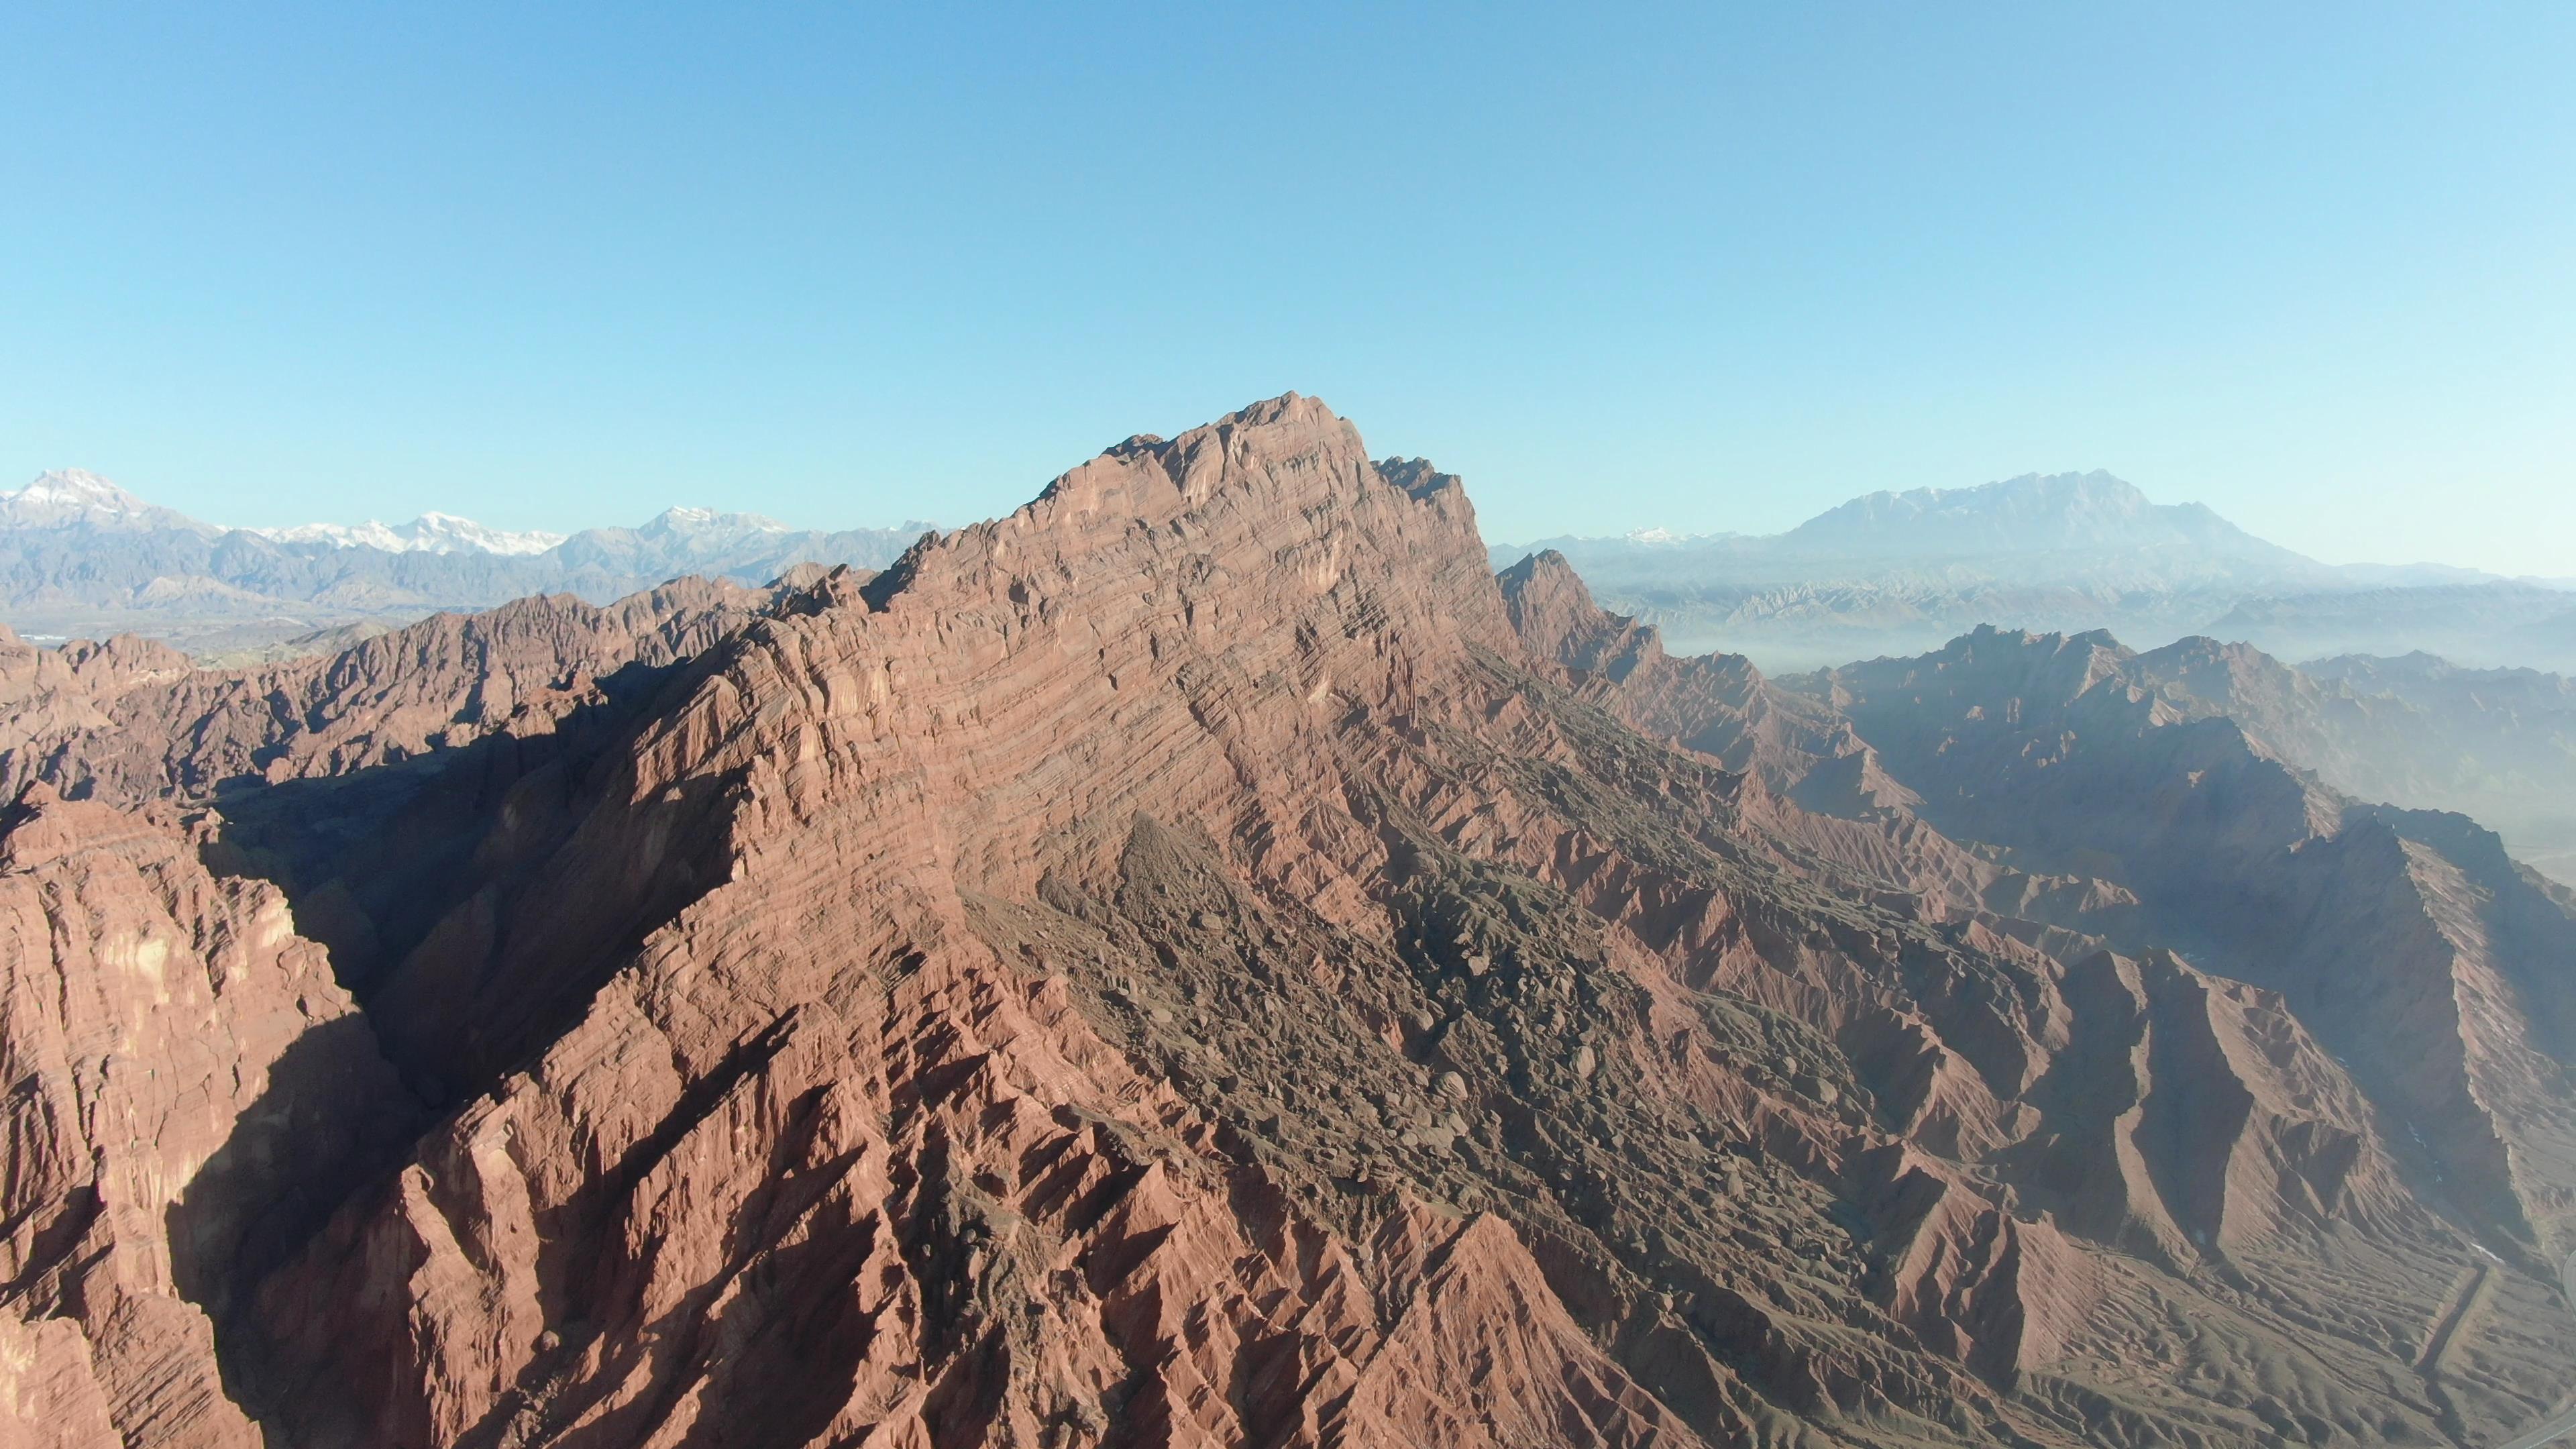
[231,400,1792,1441]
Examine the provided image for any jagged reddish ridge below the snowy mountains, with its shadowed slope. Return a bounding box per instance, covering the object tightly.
[0,580,794,1005]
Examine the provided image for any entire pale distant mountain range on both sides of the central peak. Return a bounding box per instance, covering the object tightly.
[20,459,2576,673]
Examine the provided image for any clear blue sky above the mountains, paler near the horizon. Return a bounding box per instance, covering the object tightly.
[0,0,2576,575]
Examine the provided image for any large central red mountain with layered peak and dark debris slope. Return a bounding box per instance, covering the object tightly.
[231,400,2555,1444]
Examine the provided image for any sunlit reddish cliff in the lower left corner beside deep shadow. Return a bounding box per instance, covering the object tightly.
[0,786,402,1449]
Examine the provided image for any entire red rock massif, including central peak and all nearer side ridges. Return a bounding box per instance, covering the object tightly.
[0,397,2576,1446]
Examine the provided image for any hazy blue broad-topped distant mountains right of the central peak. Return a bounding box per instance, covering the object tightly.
[1491,472,2576,670]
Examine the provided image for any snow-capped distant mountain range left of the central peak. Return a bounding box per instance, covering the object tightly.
[0,470,932,657]
